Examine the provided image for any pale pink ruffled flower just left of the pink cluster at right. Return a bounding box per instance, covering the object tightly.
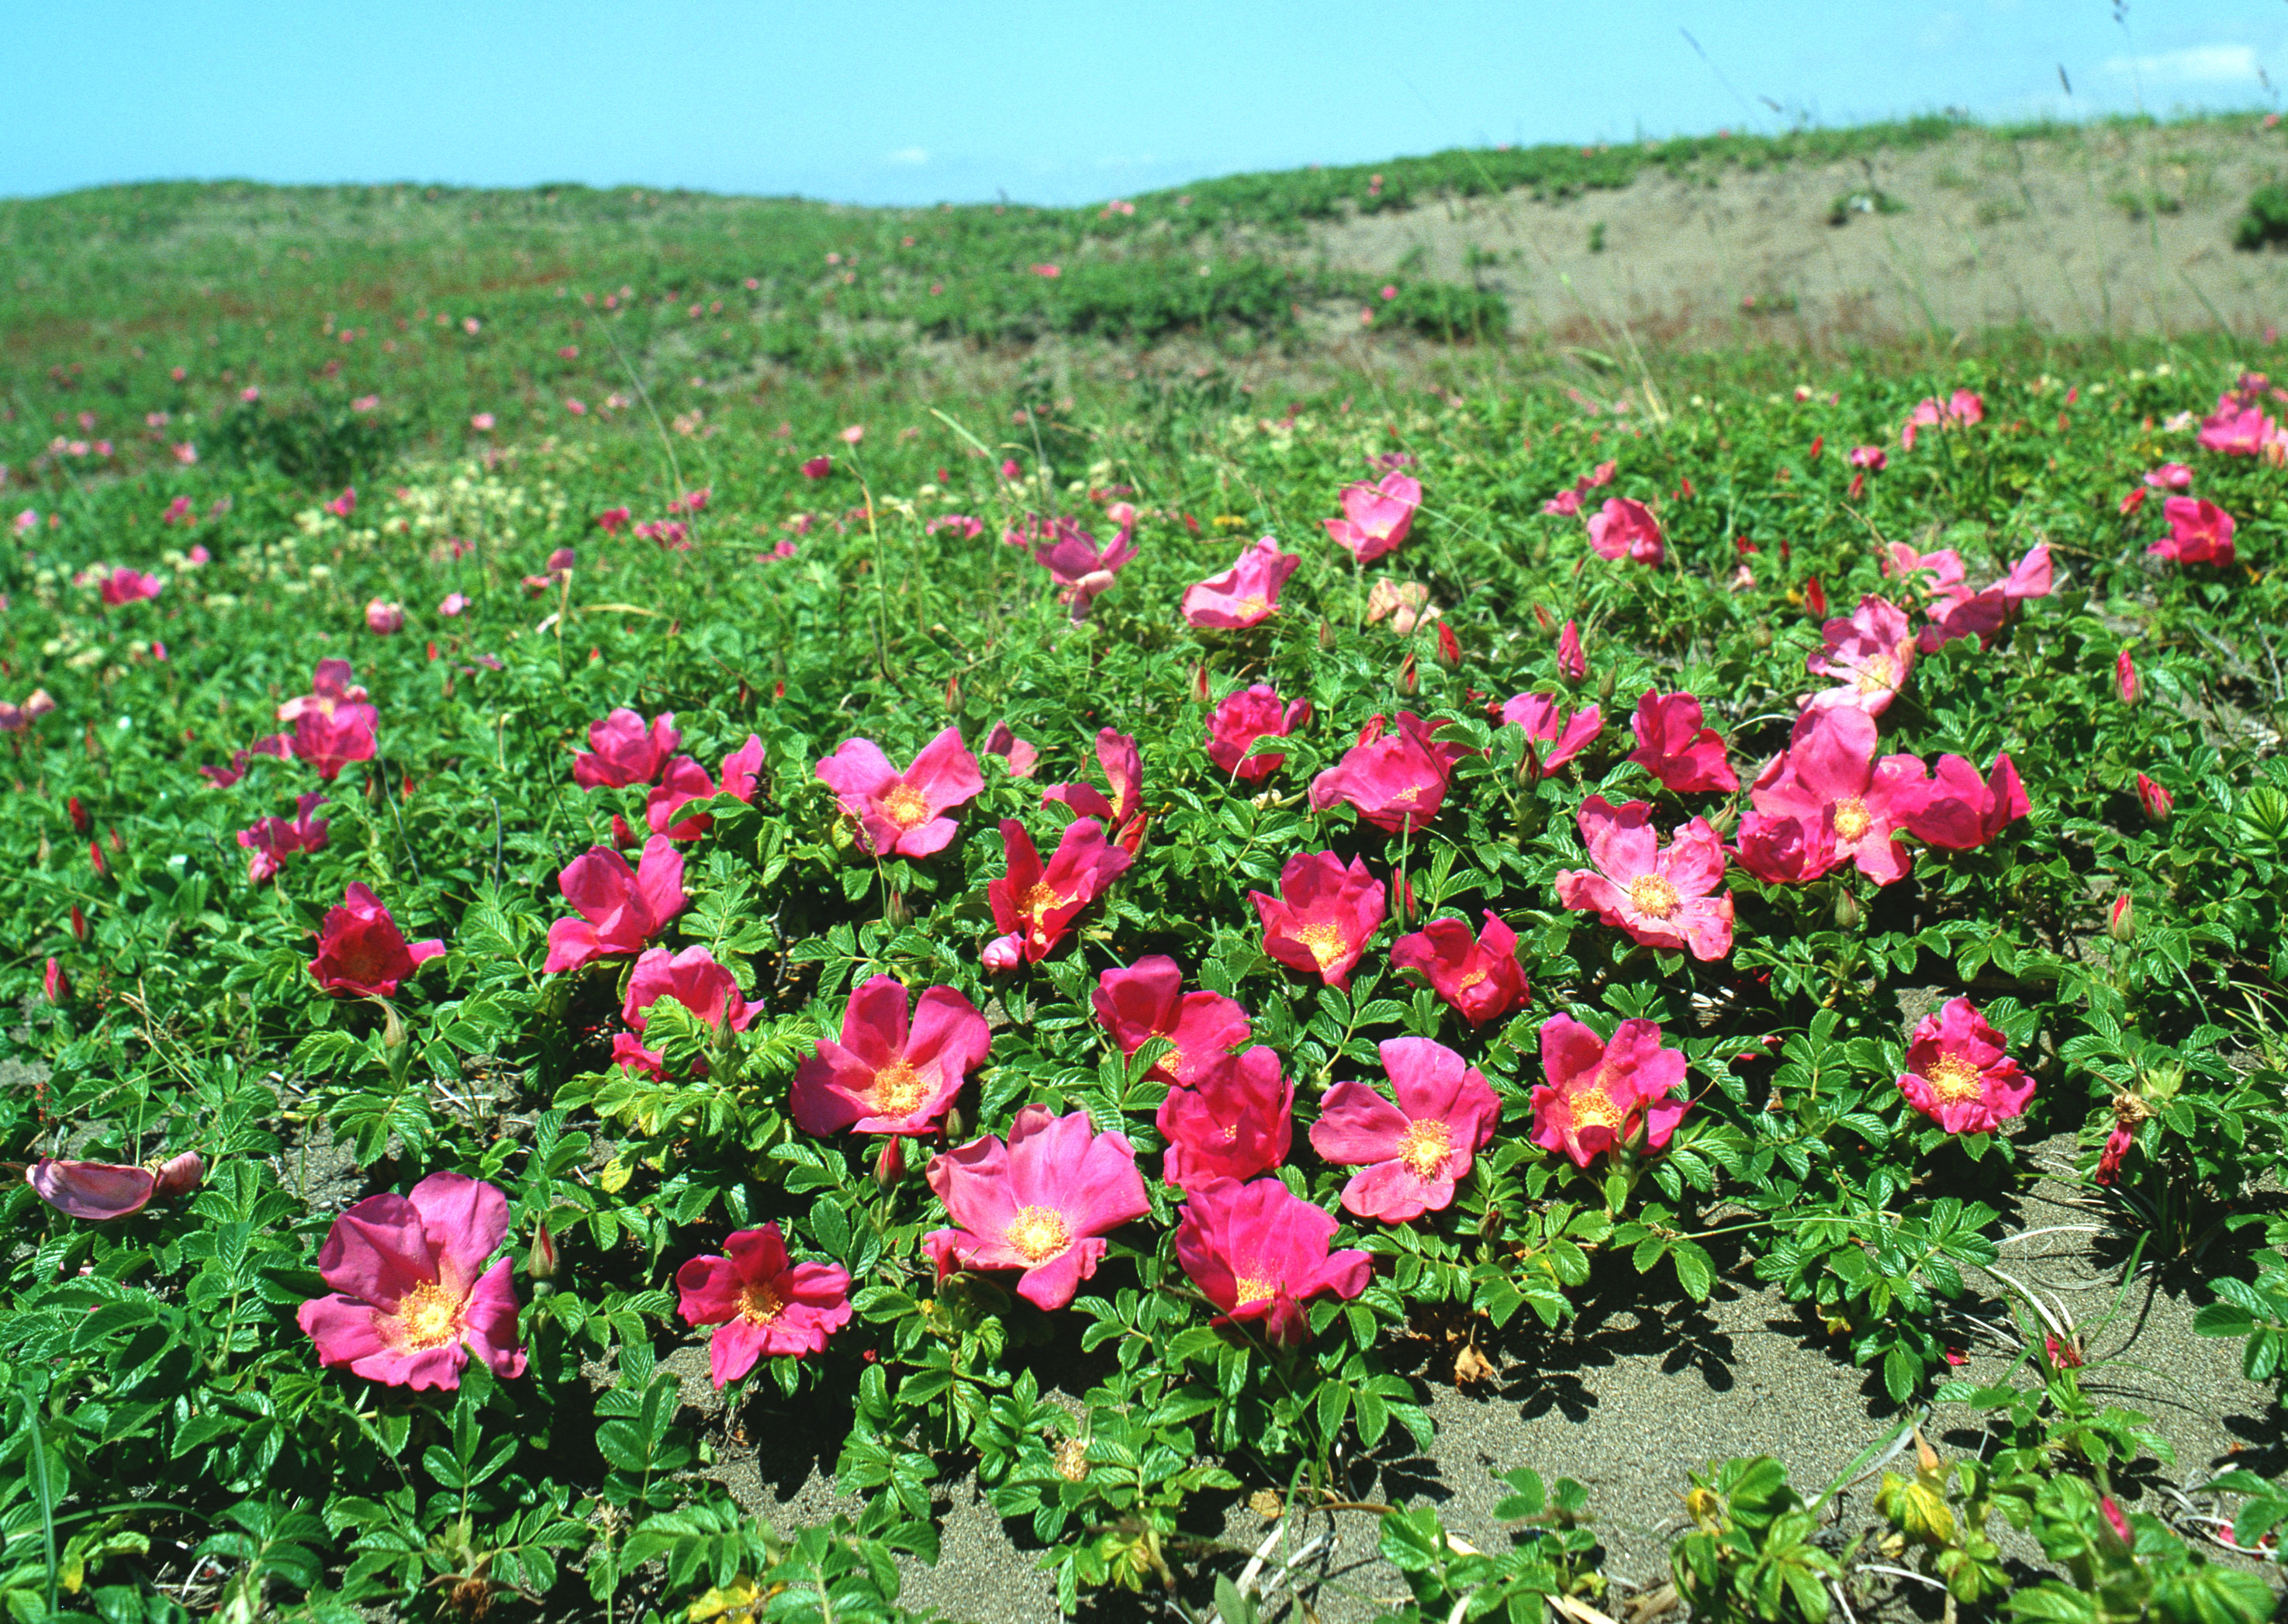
[1558,796,1732,961]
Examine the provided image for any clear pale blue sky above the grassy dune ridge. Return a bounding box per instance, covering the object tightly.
[0,0,2288,203]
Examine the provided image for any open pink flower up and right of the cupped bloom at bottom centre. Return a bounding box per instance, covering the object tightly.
[1311,1038,1501,1224]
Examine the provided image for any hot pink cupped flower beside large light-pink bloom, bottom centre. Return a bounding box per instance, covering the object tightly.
[1176,1178,1375,1347]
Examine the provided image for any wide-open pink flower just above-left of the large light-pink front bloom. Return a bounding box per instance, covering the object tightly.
[794,974,993,1137]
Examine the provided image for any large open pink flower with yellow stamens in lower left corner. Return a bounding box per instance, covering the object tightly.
[296,1173,524,1391]
